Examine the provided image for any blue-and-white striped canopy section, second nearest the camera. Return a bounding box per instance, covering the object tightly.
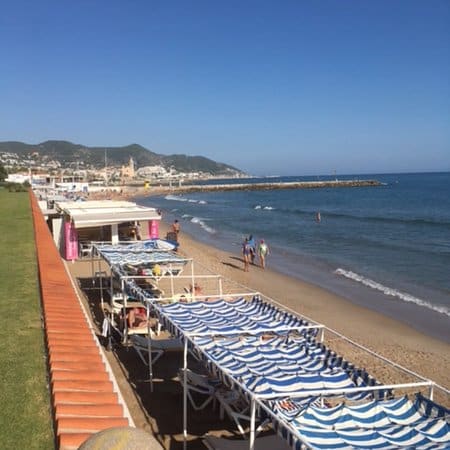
[189,334,380,399]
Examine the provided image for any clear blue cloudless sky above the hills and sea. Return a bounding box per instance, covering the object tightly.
[0,0,450,175]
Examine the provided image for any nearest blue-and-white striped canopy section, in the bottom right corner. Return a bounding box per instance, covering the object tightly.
[272,395,450,450]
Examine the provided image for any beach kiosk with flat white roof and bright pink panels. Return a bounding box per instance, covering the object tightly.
[52,200,161,260]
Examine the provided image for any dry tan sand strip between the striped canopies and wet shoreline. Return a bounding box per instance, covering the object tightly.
[160,221,450,389]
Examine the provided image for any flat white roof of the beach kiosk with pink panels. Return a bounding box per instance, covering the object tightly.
[56,200,161,228]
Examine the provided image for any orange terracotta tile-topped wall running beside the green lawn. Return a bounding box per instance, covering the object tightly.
[30,190,131,450]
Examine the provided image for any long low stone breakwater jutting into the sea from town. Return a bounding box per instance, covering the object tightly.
[171,180,382,193]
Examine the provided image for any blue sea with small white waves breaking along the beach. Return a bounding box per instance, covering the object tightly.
[137,172,450,342]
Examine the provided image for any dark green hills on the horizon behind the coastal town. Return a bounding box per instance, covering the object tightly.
[0,141,243,176]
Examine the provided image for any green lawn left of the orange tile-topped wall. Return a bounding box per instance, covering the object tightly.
[0,188,54,449]
